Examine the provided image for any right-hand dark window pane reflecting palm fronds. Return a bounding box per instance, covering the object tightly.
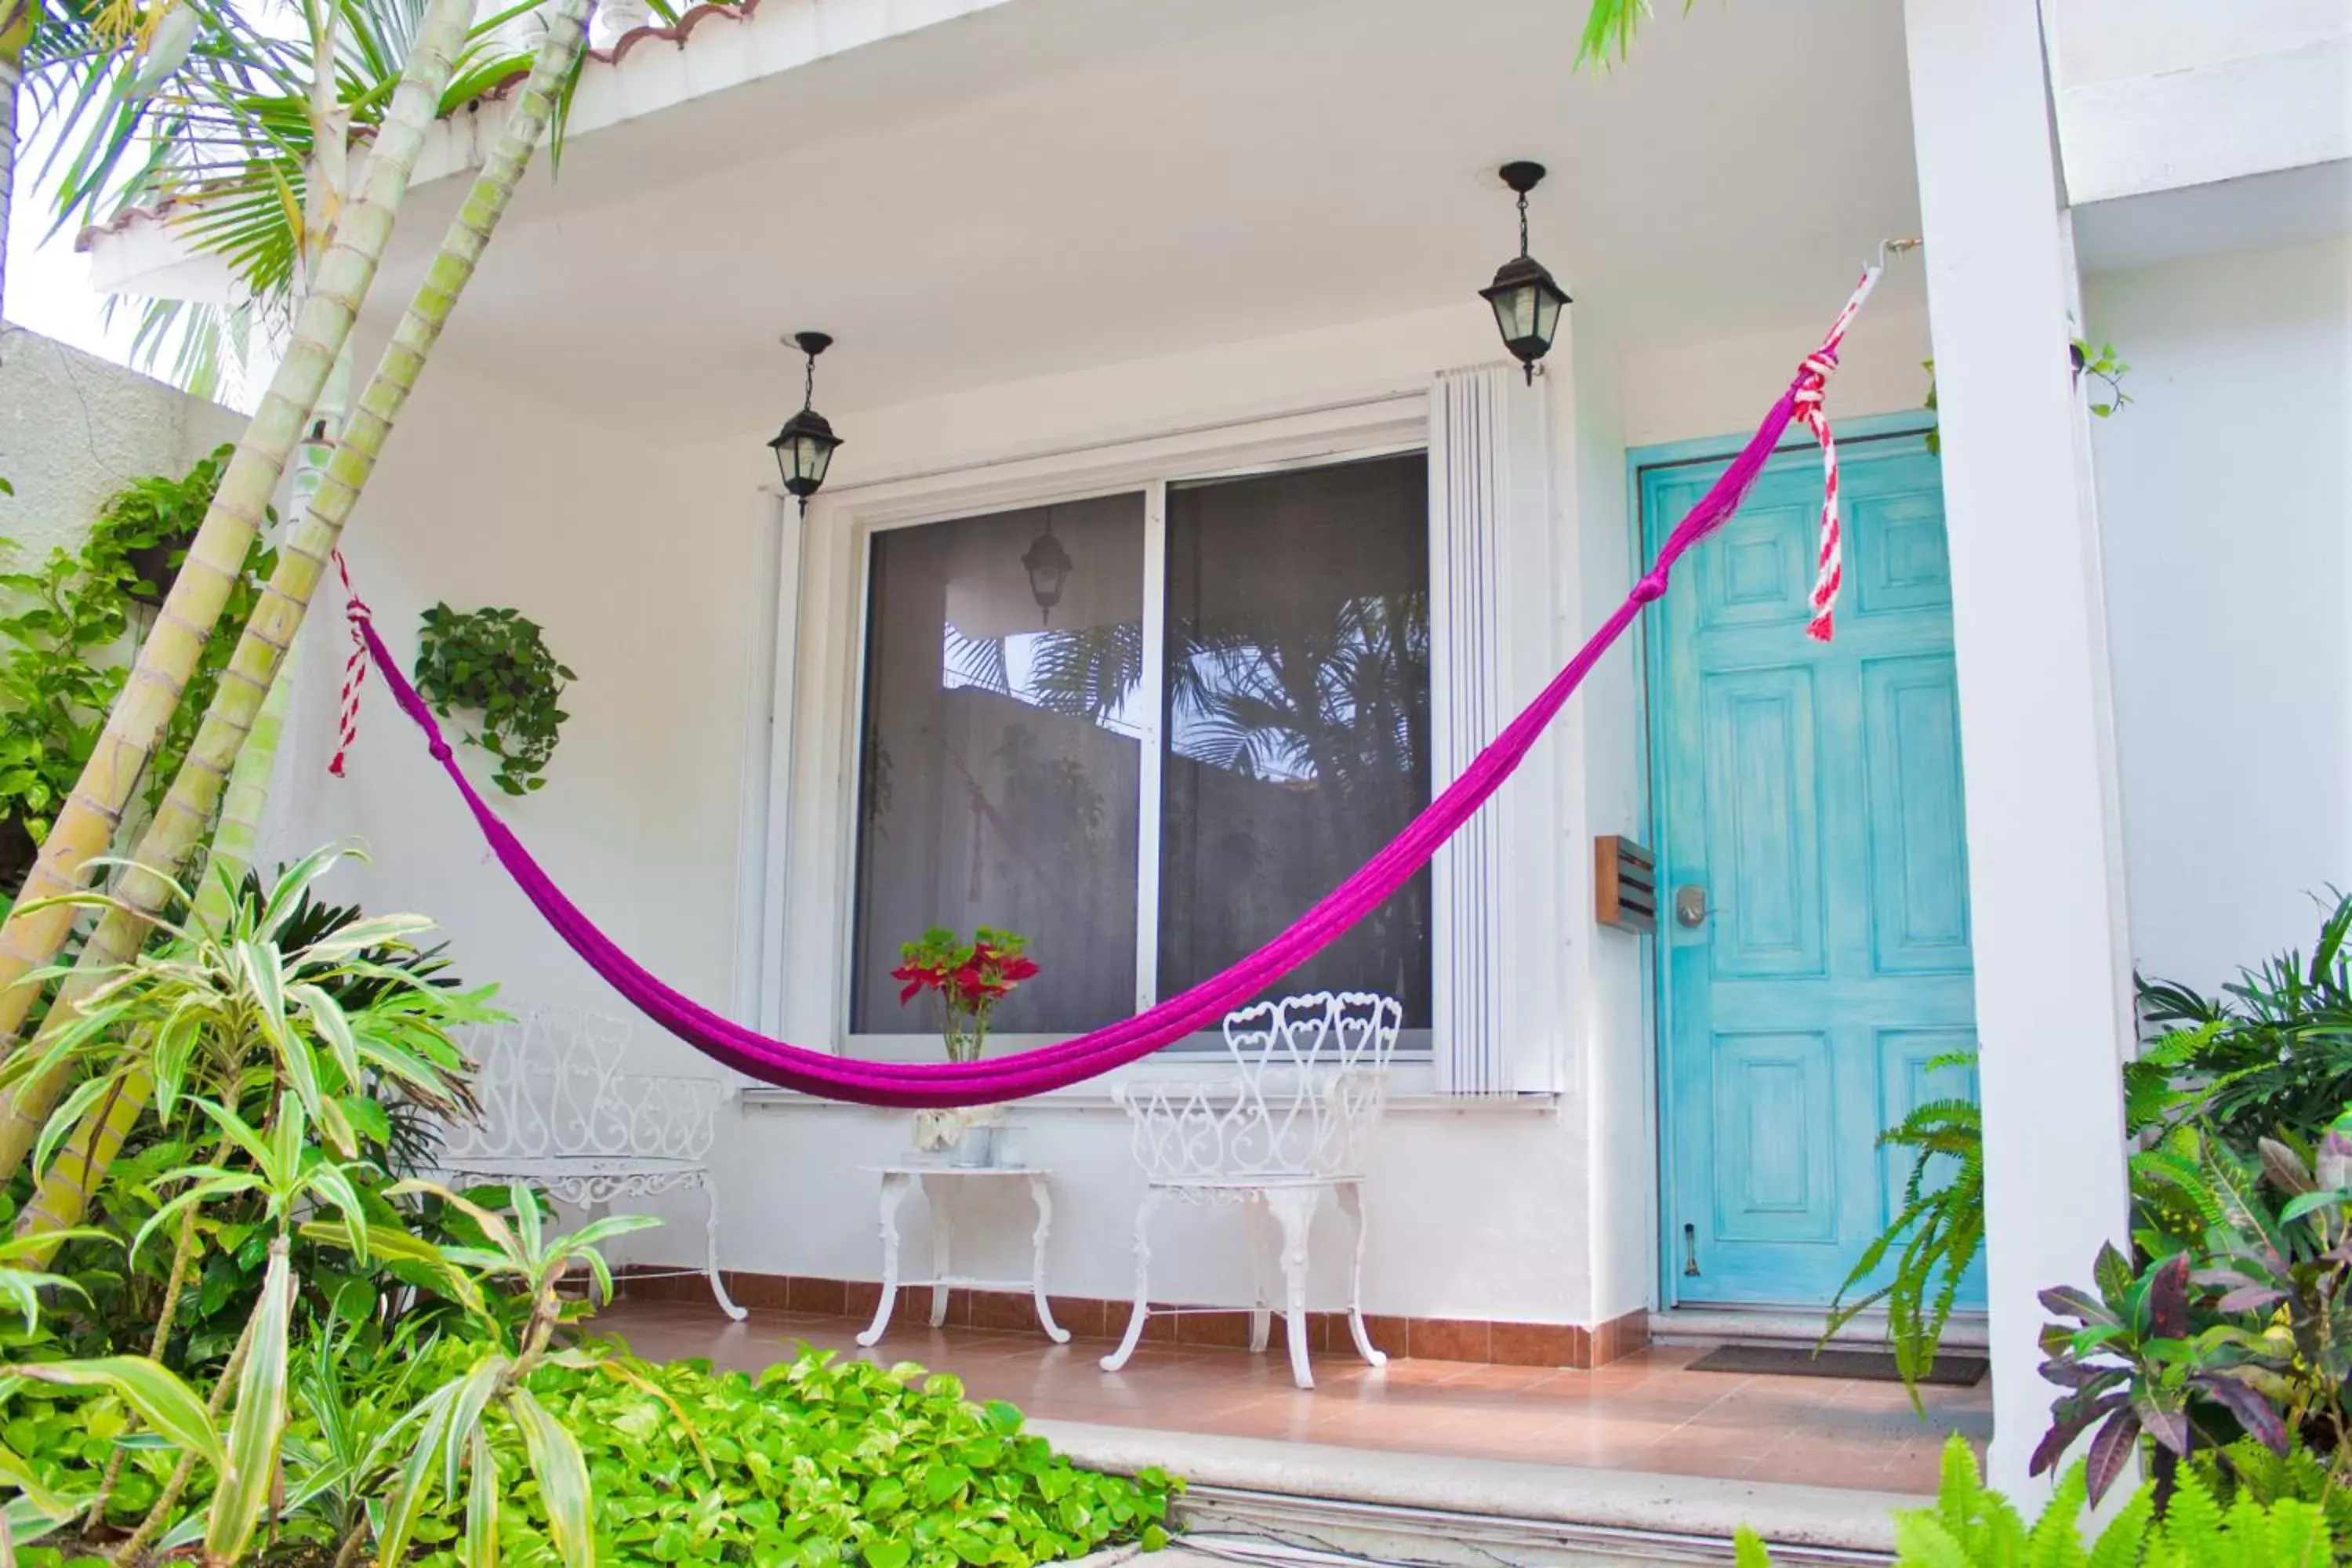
[1160,454,1430,1027]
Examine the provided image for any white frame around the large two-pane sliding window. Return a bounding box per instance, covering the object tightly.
[757,390,1449,1072]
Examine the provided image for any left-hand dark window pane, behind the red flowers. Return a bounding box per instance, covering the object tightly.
[849,496,1148,1034]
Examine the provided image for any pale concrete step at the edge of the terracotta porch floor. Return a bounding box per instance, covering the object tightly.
[1033,1420,1926,1568]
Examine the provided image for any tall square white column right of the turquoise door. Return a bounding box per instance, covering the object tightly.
[1903,0,2131,1495]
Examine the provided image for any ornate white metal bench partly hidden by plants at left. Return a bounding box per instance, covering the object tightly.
[435,1008,743,1319]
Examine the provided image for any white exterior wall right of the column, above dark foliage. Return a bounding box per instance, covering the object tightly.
[2084,240,2352,987]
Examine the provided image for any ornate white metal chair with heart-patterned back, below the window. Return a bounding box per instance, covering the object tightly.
[1103,992,1404,1389]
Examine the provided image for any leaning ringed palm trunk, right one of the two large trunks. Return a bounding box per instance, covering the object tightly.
[0,0,593,1234]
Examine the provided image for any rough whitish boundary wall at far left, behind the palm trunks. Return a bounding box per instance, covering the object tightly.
[0,327,245,567]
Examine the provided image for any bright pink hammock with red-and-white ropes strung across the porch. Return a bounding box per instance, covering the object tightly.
[332,268,1879,1107]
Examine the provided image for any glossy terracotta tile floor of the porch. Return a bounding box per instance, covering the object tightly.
[597,1302,1992,1493]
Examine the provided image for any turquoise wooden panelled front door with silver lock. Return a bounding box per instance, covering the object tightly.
[1642,435,1973,1307]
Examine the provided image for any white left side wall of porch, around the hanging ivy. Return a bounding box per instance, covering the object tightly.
[287,350,748,1004]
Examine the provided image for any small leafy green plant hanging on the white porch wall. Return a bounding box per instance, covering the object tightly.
[416,604,579,794]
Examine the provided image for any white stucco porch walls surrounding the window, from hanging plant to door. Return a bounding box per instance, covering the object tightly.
[294,288,1924,1323]
